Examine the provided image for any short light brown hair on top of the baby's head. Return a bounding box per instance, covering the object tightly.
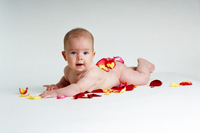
[64,28,94,51]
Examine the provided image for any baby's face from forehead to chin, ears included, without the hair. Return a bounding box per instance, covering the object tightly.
[63,37,95,73]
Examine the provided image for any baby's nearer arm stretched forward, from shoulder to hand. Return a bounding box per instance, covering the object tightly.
[40,71,98,98]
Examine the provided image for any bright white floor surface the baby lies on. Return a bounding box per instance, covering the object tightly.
[0,73,200,133]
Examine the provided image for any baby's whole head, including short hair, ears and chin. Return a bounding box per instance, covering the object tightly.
[62,28,95,73]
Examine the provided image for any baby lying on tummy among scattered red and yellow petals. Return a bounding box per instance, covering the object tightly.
[40,28,155,98]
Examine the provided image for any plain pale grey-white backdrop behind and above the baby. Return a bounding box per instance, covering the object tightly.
[0,0,200,89]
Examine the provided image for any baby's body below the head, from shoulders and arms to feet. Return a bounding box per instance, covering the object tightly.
[41,58,155,98]
